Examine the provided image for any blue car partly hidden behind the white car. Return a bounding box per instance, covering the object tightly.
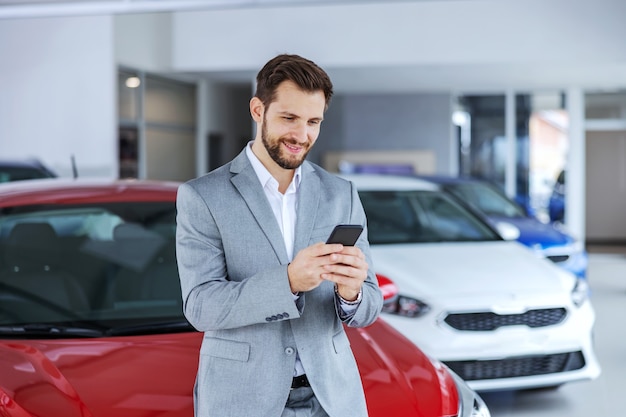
[420,176,588,278]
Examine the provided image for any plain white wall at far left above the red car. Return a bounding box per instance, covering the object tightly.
[0,16,118,177]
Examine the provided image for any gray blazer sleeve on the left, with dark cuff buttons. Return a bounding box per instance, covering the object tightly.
[176,183,300,331]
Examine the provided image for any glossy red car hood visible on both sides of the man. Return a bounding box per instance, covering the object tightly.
[0,320,458,417]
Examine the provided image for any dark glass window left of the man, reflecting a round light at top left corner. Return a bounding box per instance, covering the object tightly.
[118,69,196,181]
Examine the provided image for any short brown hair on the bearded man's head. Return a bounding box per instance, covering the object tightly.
[254,54,333,108]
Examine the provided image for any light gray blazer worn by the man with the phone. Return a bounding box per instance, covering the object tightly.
[176,151,382,417]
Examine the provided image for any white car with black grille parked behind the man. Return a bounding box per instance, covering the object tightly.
[342,174,600,391]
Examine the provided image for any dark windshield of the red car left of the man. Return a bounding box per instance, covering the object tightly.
[0,202,190,338]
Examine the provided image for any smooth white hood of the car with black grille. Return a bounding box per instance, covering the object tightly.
[371,241,574,298]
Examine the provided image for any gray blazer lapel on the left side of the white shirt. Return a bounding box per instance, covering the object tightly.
[230,149,288,264]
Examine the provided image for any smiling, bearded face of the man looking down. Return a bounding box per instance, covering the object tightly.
[261,81,326,169]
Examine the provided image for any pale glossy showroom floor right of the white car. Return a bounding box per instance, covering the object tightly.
[482,246,626,417]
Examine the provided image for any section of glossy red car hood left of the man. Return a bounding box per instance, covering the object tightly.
[0,333,202,417]
